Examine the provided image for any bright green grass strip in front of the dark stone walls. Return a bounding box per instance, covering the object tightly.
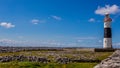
[0,62,97,68]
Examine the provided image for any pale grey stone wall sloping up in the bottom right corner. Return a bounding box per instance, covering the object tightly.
[94,50,120,68]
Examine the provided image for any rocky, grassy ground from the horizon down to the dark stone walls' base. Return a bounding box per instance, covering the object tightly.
[0,47,112,64]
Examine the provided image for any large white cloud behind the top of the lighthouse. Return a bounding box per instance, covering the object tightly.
[95,5,120,15]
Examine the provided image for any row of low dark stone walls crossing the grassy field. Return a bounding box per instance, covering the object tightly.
[0,55,100,64]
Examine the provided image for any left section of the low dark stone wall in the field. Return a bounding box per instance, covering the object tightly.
[0,55,50,63]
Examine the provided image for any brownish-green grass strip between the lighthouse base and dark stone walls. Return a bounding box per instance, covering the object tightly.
[0,51,113,62]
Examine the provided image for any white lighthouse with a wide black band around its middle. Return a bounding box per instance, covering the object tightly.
[103,13,112,49]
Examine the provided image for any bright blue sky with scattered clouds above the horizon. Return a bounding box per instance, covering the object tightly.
[0,0,120,47]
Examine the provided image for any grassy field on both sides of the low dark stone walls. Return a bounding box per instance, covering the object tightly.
[0,50,113,68]
